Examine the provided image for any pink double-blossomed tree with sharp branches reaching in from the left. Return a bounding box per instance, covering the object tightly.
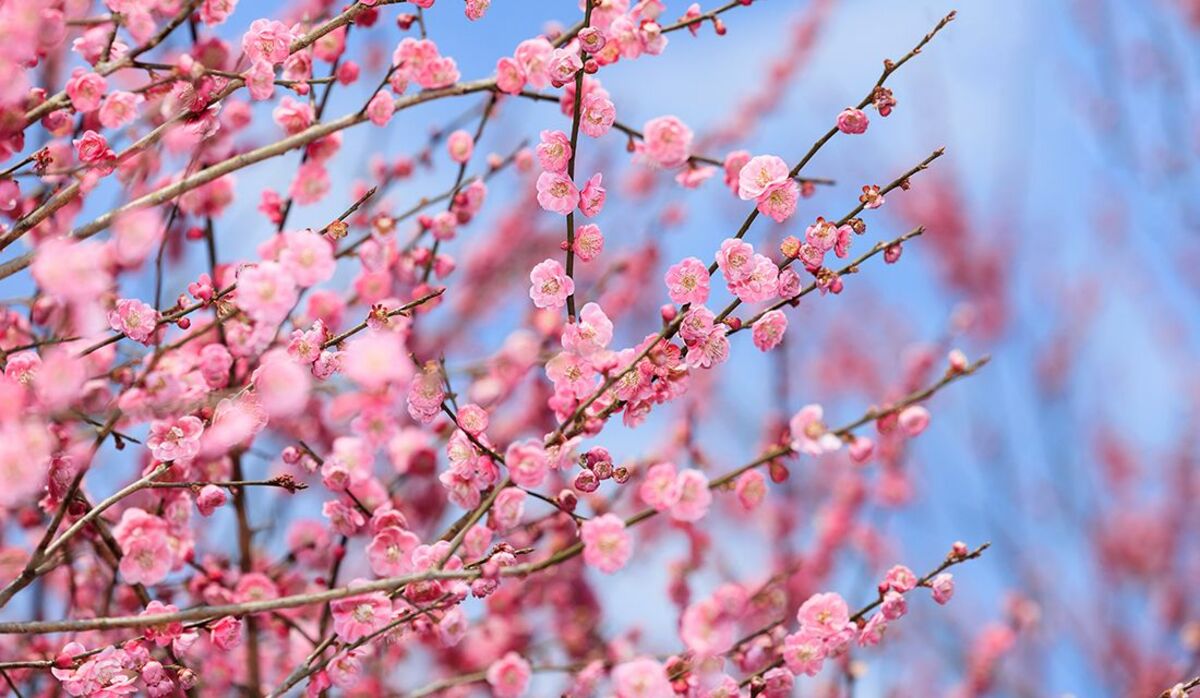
[0,0,1089,698]
